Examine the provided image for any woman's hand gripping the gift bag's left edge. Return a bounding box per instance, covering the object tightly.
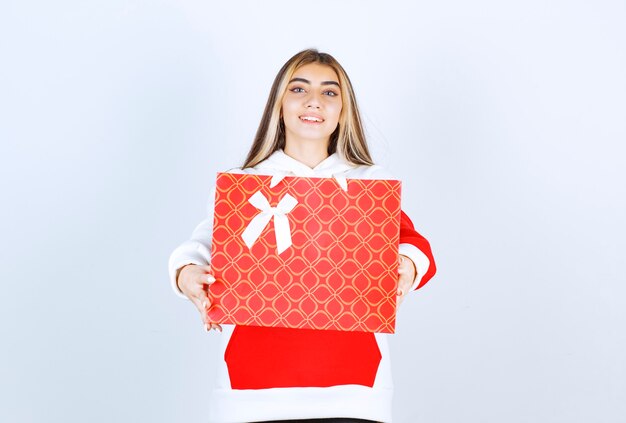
[176,264,222,332]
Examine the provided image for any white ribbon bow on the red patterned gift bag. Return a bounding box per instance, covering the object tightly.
[241,191,298,254]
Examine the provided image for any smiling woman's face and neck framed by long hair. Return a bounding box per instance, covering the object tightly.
[281,63,342,148]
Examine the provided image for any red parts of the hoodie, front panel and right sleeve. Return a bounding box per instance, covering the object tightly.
[224,212,436,389]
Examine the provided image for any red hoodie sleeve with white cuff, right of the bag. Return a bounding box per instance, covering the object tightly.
[399,211,437,290]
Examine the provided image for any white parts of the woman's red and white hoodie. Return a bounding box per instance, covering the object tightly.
[169,150,430,423]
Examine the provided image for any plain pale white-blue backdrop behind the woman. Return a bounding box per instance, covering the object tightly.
[0,0,626,423]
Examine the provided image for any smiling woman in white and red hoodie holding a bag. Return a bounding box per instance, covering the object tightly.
[169,50,435,422]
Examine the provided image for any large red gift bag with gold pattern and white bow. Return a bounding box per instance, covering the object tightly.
[207,173,400,333]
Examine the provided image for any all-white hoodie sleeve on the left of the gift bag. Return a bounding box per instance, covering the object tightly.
[168,189,215,298]
